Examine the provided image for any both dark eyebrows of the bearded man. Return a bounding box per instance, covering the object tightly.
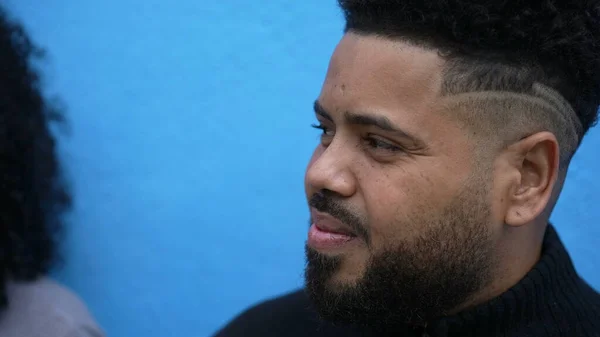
[314,100,427,149]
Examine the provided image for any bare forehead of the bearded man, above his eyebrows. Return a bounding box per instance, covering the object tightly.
[319,33,443,123]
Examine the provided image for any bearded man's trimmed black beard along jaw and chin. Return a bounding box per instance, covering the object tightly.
[305,190,494,330]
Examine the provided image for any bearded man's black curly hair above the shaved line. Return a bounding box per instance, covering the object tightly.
[338,0,600,154]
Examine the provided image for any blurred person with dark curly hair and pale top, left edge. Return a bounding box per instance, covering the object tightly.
[0,8,103,337]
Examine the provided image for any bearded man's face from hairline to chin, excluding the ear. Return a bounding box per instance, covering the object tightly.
[305,33,501,325]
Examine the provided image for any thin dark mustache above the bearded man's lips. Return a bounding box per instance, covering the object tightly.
[308,191,370,242]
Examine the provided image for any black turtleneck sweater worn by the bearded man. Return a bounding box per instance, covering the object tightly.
[215,226,600,337]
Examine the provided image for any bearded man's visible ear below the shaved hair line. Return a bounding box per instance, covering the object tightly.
[504,131,560,226]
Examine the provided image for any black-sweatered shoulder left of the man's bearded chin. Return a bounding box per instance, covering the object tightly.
[214,290,358,337]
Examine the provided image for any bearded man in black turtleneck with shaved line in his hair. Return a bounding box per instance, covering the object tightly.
[217,0,600,337]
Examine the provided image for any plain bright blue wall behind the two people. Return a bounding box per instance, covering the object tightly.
[5,0,600,337]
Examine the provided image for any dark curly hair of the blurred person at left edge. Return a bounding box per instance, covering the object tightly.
[0,8,71,307]
